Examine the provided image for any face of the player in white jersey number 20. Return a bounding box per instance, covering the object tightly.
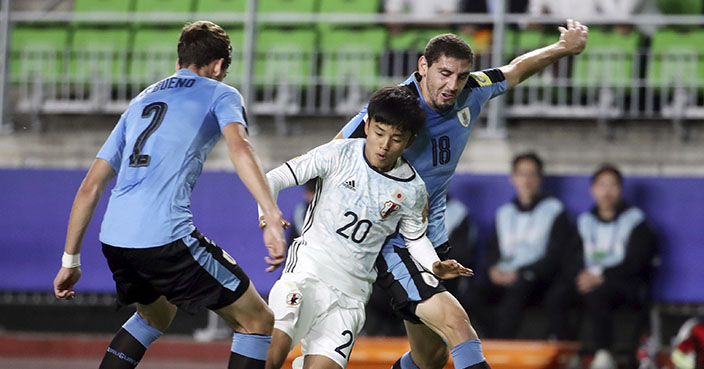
[364,118,413,172]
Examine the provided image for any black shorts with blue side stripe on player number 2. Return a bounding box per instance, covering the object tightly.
[103,230,249,314]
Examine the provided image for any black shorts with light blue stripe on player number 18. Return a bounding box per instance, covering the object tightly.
[376,239,450,324]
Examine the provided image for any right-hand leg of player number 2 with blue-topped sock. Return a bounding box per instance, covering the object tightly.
[215,282,274,369]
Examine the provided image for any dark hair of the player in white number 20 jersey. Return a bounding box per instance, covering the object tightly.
[367,86,425,134]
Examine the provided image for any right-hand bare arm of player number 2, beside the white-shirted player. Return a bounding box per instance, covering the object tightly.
[222,123,286,265]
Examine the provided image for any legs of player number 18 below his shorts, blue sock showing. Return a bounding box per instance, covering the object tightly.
[408,291,489,369]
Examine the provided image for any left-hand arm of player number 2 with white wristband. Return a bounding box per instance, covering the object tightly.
[54,159,115,299]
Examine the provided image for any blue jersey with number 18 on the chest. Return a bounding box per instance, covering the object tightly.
[342,69,506,247]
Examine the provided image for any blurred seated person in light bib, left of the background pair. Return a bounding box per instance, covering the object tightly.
[468,152,574,338]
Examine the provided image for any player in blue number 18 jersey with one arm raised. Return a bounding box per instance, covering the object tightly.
[337,19,588,369]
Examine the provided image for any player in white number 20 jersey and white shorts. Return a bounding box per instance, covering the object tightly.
[264,86,471,369]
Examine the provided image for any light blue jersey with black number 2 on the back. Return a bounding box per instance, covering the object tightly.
[97,69,246,248]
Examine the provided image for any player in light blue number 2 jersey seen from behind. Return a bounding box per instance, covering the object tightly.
[54,21,285,369]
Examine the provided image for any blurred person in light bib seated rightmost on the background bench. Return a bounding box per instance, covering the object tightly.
[553,164,657,369]
